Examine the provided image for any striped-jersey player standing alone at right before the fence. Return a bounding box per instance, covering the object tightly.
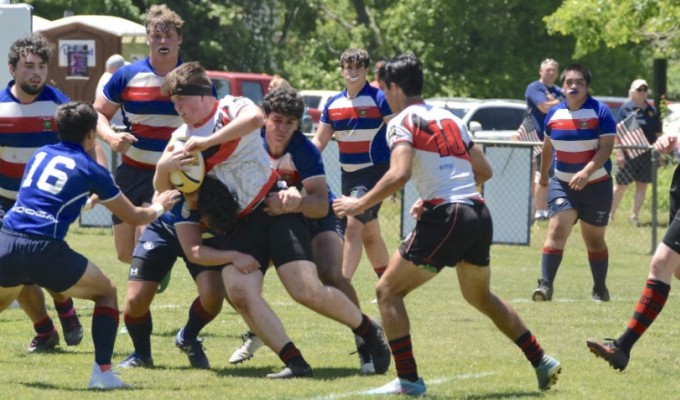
[532,64,616,301]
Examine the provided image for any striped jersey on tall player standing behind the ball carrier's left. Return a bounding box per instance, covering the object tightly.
[104,58,183,169]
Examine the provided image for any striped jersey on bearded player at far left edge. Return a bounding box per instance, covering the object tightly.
[0,81,69,200]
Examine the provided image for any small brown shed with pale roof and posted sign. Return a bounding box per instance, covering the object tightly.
[33,15,148,102]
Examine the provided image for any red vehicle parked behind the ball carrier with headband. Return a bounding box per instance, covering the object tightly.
[206,71,272,105]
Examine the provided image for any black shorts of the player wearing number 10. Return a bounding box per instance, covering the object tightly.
[399,202,493,272]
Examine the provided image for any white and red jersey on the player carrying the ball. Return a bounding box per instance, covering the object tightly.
[172,96,277,217]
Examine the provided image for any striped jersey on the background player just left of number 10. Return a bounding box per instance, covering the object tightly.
[319,83,392,172]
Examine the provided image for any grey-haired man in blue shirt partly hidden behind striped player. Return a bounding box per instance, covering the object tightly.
[524,58,564,220]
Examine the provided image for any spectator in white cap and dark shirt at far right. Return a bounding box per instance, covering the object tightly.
[609,79,661,225]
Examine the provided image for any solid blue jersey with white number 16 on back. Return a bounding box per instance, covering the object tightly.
[4,142,121,240]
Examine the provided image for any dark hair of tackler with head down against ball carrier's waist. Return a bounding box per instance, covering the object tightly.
[198,176,239,233]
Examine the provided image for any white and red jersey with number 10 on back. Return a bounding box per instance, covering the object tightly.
[387,103,482,204]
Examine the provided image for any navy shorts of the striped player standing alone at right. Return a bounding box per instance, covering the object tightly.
[548,177,612,226]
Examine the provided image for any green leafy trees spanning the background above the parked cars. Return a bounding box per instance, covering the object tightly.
[21,0,660,98]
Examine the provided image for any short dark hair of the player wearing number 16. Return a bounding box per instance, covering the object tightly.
[56,101,99,143]
